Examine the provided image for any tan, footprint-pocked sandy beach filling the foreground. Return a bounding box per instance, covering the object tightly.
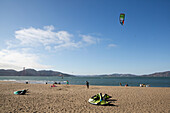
[0,82,170,113]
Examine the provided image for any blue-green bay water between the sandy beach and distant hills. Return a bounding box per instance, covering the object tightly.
[0,76,170,87]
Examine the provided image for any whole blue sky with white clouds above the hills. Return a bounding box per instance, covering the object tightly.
[0,0,170,75]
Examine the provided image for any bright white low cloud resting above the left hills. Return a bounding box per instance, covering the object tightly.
[0,49,52,70]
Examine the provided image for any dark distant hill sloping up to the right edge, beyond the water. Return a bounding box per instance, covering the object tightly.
[142,71,170,77]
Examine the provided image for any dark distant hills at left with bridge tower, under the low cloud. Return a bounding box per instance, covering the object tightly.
[0,69,73,77]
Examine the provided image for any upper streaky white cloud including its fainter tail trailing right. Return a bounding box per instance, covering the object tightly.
[7,26,99,50]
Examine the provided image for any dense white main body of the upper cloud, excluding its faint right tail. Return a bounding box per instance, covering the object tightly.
[15,26,66,46]
